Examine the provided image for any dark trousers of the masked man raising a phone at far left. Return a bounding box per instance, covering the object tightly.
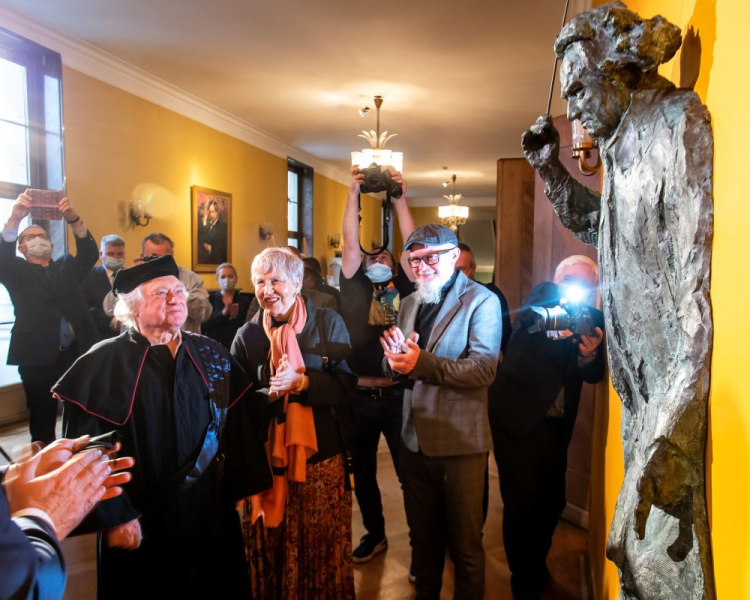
[18,348,75,444]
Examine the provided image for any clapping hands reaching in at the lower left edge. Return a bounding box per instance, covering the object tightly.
[3,449,124,540]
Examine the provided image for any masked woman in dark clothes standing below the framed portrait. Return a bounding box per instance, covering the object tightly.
[201,263,251,350]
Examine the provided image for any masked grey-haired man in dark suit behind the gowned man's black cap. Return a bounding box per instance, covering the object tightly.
[81,235,125,339]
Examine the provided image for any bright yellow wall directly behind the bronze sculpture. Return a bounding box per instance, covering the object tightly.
[592,0,750,599]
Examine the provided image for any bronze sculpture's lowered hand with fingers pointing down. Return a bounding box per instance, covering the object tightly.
[635,437,700,561]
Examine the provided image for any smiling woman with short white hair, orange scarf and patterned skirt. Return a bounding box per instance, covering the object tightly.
[232,248,356,599]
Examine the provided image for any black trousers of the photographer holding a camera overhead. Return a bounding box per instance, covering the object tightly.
[352,388,404,539]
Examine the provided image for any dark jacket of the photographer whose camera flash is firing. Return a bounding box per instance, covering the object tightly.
[490,282,604,440]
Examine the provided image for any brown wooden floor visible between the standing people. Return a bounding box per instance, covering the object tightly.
[0,425,589,600]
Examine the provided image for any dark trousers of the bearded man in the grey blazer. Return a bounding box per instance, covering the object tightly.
[401,445,487,600]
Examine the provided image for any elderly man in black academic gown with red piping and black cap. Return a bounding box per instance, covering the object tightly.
[53,255,271,600]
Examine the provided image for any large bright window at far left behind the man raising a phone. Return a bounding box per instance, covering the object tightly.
[0,28,66,386]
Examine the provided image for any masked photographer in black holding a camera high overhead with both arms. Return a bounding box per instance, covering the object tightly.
[340,166,414,563]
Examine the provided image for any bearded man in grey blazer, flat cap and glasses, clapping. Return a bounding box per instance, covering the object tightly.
[381,224,502,599]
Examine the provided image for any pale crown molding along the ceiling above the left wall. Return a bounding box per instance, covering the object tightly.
[0,8,350,186]
